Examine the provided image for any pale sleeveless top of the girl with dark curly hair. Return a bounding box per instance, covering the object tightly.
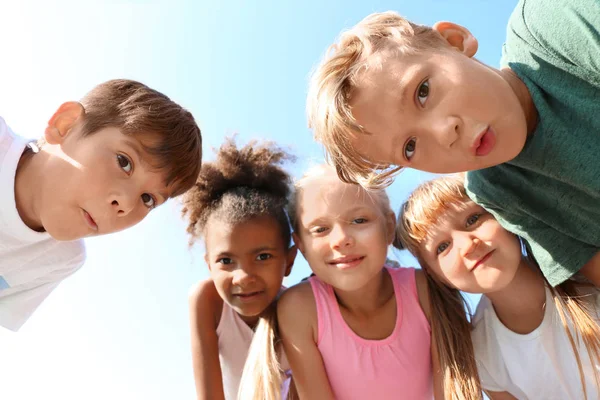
[217,302,290,400]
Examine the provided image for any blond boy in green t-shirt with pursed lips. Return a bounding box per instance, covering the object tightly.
[308,0,600,287]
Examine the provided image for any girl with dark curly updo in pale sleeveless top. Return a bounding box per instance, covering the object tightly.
[183,140,296,400]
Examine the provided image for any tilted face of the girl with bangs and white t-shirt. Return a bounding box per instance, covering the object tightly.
[419,200,522,294]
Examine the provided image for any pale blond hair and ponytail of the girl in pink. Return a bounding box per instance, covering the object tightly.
[238,164,393,400]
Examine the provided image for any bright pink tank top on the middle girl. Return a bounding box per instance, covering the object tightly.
[310,267,433,400]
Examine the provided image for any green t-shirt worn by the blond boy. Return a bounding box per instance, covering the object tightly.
[466,0,600,286]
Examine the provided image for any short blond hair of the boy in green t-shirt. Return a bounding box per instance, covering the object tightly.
[307,11,447,188]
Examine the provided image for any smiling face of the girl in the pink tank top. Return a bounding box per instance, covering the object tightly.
[295,173,395,291]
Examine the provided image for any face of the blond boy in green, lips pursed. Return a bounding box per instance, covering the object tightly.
[350,48,527,173]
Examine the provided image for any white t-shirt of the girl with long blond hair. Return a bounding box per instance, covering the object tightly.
[472,288,600,400]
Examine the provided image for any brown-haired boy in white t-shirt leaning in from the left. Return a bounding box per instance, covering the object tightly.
[0,80,202,331]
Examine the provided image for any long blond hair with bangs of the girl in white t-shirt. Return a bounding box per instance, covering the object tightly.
[394,175,600,399]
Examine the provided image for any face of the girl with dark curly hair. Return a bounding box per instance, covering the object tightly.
[205,216,296,325]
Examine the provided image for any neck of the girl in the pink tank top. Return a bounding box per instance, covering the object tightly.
[333,268,394,316]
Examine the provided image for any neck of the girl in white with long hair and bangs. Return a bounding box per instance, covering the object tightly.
[486,259,552,334]
